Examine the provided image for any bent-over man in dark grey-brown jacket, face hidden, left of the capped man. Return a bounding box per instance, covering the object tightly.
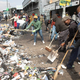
[53,14,68,52]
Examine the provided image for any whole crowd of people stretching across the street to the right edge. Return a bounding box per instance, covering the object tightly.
[11,6,80,69]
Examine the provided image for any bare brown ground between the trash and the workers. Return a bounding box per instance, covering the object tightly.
[0,20,80,80]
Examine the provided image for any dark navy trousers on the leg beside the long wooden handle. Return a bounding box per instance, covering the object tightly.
[67,47,79,69]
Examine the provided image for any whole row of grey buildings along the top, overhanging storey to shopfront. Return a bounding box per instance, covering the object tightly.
[22,0,79,19]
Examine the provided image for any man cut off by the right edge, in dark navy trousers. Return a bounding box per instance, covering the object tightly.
[64,6,80,69]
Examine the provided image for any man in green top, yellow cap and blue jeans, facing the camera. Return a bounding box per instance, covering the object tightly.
[26,15,45,45]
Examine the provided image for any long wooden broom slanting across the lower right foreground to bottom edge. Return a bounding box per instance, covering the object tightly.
[54,30,78,80]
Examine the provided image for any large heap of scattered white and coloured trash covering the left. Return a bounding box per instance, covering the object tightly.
[0,25,63,80]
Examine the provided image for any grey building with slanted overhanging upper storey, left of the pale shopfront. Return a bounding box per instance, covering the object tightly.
[22,0,48,15]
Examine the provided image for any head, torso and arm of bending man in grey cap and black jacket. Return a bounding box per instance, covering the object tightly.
[61,16,77,46]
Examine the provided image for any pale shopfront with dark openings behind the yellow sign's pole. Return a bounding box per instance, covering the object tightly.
[43,0,80,19]
